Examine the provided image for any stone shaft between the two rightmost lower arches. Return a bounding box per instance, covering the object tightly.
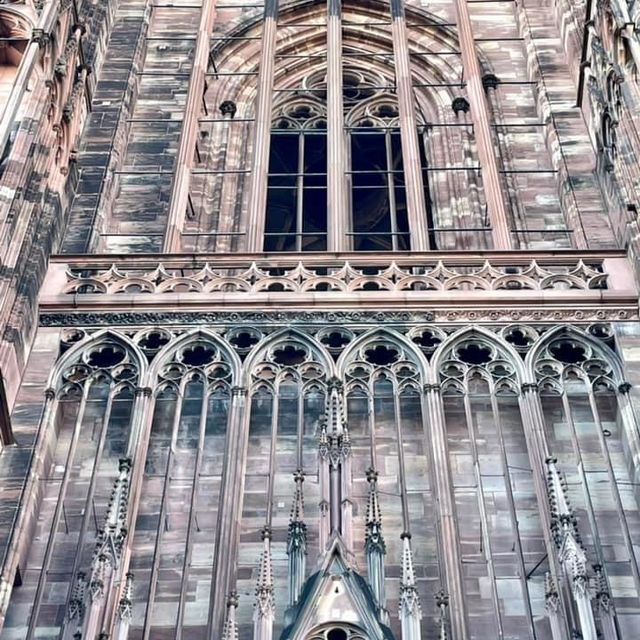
[519,382,571,640]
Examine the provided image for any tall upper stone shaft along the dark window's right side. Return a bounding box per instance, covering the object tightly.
[391,0,431,251]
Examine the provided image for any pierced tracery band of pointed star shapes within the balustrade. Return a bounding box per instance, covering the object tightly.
[64,260,607,294]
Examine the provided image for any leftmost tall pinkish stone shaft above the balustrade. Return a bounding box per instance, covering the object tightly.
[164,0,216,253]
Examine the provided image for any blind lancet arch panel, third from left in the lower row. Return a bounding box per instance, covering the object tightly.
[237,334,331,637]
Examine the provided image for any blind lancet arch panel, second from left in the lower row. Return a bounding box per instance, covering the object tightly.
[128,334,233,639]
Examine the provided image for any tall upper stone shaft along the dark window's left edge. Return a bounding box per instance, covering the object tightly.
[245,0,278,255]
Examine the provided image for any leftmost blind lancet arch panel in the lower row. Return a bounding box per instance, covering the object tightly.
[15,334,143,639]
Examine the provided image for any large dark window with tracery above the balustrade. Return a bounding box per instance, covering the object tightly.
[264,70,433,252]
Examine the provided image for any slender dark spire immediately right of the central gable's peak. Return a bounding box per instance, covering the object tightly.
[364,467,388,624]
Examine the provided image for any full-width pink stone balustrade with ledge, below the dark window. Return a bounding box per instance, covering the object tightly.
[40,251,638,325]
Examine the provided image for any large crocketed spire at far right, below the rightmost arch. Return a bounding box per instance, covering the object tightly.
[546,458,597,640]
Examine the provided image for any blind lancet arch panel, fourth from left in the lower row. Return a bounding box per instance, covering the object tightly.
[341,334,441,637]
